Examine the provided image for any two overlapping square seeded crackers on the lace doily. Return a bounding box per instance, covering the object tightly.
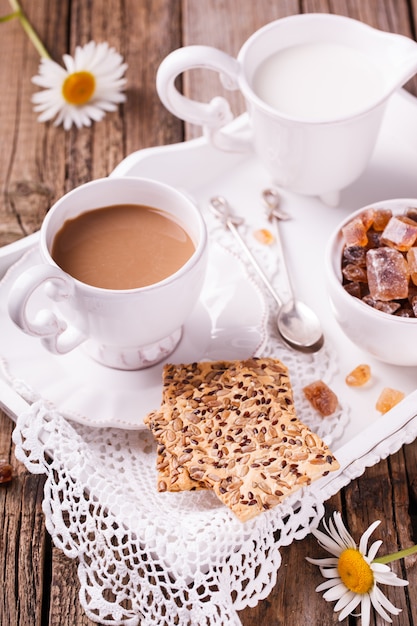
[145,358,339,521]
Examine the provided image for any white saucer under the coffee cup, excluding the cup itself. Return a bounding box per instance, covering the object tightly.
[0,242,267,429]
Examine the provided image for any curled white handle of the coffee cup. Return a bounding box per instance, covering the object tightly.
[8,265,87,354]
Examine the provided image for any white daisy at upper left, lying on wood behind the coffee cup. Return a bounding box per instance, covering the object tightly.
[32,41,127,130]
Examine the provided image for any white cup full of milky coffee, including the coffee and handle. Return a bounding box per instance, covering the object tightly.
[8,177,208,369]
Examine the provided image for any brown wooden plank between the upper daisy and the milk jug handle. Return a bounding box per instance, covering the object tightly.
[44,0,183,626]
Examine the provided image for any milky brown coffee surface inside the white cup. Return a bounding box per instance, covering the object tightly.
[51,204,195,289]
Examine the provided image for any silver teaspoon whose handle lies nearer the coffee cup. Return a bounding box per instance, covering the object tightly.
[210,196,324,352]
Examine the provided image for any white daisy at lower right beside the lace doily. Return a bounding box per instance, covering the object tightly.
[307,512,408,626]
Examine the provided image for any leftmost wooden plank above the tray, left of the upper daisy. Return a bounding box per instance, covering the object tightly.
[0,0,66,245]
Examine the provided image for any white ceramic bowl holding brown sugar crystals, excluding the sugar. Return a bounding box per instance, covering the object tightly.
[325,198,417,366]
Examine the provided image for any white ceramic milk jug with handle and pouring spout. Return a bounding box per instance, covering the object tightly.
[157,13,417,205]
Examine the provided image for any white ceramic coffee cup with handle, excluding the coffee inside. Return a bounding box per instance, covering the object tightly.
[8,177,208,370]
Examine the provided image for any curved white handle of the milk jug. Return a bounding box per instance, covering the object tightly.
[156,46,251,152]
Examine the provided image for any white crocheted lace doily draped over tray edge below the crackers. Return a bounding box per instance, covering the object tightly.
[14,402,324,626]
